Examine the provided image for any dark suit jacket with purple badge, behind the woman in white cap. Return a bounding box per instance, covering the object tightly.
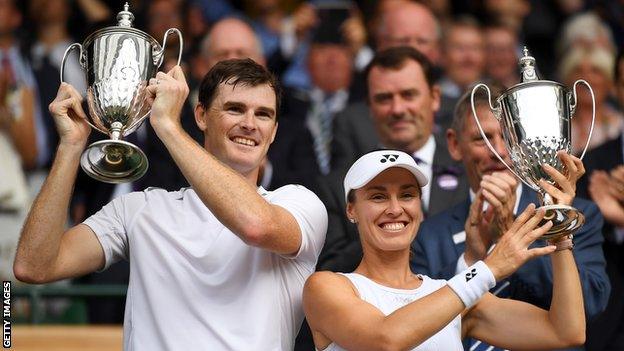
[314,133,469,272]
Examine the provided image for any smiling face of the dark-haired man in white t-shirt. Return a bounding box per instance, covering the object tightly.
[195,83,277,181]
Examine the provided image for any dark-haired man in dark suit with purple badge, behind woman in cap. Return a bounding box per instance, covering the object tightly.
[317,47,468,272]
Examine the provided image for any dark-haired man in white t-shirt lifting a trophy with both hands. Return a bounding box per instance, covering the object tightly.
[14,59,327,350]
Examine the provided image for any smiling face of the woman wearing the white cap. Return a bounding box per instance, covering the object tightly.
[347,167,423,251]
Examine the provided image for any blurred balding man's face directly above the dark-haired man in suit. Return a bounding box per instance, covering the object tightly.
[377,3,440,64]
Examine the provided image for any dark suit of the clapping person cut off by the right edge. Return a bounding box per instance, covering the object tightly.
[578,134,624,350]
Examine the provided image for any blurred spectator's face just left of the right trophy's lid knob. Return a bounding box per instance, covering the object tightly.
[485,28,518,82]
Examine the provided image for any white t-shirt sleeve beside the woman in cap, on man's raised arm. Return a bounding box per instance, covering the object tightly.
[270,185,327,271]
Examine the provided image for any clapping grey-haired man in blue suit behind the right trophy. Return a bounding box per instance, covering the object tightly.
[412,88,610,349]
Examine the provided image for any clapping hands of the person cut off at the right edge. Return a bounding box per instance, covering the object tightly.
[588,170,624,227]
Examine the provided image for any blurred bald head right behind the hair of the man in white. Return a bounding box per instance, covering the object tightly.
[205,19,265,69]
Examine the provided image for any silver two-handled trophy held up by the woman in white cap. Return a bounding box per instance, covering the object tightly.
[471,47,596,239]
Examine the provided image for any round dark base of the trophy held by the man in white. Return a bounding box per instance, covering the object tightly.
[80,140,149,184]
